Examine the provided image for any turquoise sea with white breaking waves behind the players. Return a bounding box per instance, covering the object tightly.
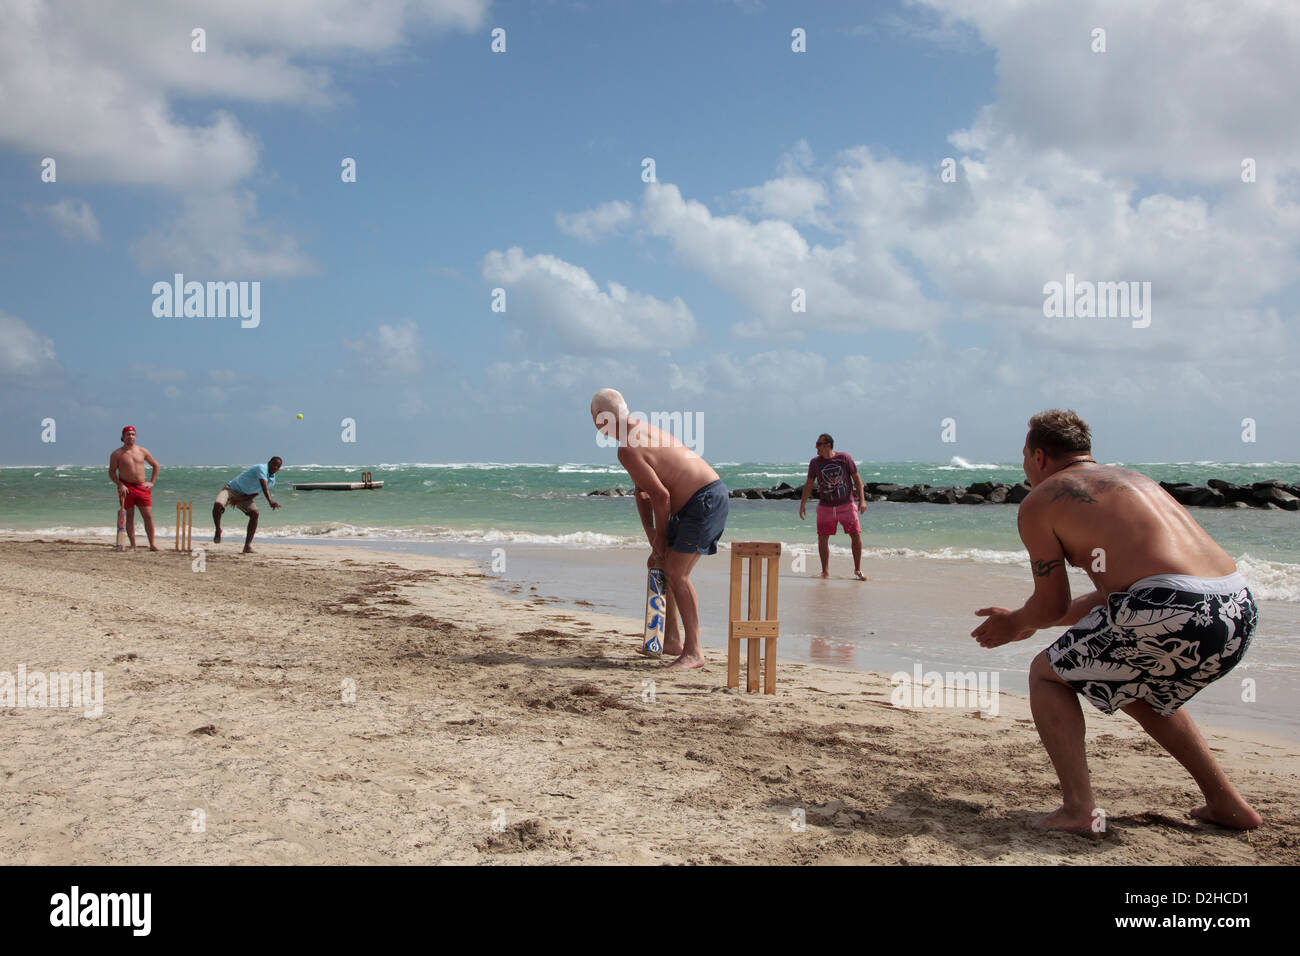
[0,453,1300,602]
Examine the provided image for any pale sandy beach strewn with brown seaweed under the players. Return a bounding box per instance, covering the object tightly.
[0,536,1300,865]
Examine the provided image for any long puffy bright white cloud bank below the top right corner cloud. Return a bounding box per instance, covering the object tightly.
[564,138,1300,364]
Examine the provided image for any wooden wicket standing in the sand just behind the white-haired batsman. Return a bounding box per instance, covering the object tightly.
[727,541,781,693]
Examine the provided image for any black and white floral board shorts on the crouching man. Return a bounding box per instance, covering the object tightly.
[1047,574,1258,717]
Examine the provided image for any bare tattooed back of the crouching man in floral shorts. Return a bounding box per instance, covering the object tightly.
[1022,462,1236,593]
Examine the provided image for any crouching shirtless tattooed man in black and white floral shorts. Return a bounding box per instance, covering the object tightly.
[971,410,1262,832]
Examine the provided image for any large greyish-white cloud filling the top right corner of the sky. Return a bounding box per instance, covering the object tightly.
[922,0,1300,180]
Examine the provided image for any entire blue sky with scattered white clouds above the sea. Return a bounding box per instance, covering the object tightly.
[0,0,1300,464]
